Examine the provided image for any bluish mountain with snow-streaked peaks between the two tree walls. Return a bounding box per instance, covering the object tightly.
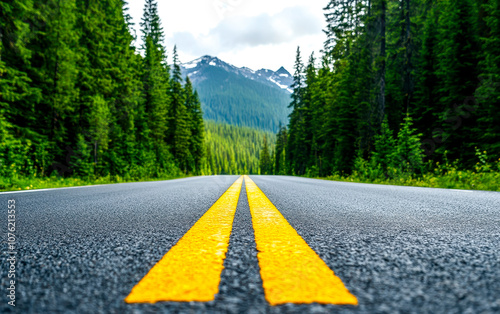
[181,56,292,132]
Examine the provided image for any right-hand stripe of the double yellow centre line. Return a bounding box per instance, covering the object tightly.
[245,176,358,305]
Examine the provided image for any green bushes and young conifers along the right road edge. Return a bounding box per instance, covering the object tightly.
[322,117,500,191]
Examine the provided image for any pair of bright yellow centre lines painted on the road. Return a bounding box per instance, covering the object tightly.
[125,176,358,305]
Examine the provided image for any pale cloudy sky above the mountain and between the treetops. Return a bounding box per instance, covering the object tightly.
[128,0,328,72]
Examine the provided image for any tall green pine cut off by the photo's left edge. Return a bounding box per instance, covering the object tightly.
[0,0,42,178]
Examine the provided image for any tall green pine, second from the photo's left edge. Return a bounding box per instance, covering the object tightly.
[24,0,80,175]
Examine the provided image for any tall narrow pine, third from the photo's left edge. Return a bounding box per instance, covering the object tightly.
[73,0,113,176]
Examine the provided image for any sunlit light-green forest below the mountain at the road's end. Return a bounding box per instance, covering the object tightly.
[203,120,274,174]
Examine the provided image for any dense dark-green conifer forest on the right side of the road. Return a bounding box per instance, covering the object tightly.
[273,0,500,179]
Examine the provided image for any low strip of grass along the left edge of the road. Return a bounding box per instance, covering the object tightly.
[0,175,190,192]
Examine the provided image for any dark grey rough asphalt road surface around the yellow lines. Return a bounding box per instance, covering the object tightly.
[0,176,500,313]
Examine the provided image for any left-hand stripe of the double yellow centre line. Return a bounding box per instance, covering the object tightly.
[125,177,243,303]
